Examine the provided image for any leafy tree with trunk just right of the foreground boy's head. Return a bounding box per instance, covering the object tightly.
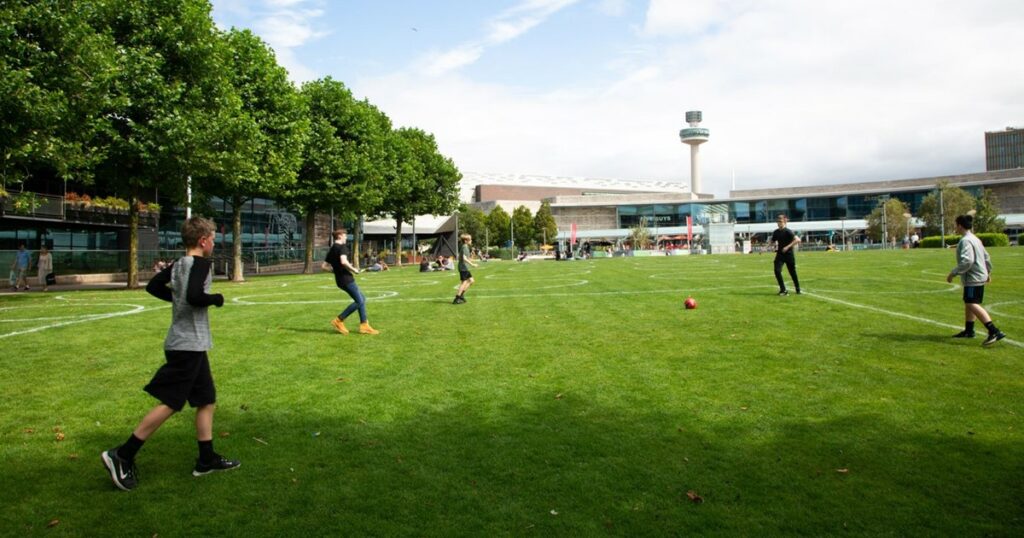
[208,30,309,282]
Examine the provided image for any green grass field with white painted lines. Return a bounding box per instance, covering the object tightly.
[0,248,1024,537]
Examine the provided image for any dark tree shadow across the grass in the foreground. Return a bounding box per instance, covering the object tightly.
[9,387,1024,536]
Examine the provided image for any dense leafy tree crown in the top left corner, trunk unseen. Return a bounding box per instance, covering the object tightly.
[0,0,117,184]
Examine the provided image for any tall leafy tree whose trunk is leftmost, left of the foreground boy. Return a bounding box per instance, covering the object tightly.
[88,0,235,288]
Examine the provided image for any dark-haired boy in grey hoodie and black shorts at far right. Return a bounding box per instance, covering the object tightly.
[946,215,1007,345]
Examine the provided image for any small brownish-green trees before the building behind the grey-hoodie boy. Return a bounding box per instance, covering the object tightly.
[867,183,1007,241]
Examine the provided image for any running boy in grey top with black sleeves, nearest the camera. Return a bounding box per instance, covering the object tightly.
[100,217,241,491]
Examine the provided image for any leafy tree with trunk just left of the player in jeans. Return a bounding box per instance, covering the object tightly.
[296,77,391,273]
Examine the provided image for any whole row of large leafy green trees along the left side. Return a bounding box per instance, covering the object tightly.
[0,0,461,287]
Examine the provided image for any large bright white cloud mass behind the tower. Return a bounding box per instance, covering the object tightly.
[366,0,1024,196]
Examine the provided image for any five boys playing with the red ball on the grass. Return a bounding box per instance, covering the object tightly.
[97,215,1006,491]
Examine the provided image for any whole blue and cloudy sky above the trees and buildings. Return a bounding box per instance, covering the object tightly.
[212,0,1024,197]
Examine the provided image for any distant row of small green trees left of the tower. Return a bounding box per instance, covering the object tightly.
[459,202,558,249]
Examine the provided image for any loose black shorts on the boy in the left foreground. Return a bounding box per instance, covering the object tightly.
[143,349,217,411]
